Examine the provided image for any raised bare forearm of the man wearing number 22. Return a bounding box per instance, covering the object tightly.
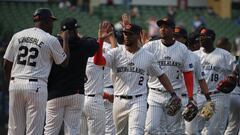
[60,30,70,67]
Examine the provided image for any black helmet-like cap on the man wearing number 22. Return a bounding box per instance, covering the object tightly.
[33,8,57,22]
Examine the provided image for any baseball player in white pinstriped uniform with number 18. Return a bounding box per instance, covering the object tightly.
[195,29,235,135]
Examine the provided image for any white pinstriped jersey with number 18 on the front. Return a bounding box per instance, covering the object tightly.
[194,48,235,92]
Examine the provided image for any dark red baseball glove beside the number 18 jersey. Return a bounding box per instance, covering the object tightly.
[217,75,237,93]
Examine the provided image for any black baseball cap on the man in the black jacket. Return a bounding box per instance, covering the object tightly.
[61,17,80,31]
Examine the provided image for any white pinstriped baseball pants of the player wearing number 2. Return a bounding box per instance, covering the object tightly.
[113,95,147,135]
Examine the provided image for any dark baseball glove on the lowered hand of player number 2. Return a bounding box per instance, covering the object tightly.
[166,95,182,116]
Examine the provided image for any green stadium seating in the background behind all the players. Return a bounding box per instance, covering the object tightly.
[0,2,240,40]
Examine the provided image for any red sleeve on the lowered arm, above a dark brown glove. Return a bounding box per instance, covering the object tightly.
[183,71,193,100]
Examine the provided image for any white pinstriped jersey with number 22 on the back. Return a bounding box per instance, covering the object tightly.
[4,28,66,83]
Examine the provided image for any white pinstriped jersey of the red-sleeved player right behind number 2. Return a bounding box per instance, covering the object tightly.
[143,40,193,92]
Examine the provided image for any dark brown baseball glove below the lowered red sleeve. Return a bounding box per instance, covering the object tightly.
[182,100,198,122]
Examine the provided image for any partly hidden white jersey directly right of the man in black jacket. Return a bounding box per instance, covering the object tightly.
[84,57,103,95]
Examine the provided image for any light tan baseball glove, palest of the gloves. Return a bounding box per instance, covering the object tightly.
[199,101,215,120]
